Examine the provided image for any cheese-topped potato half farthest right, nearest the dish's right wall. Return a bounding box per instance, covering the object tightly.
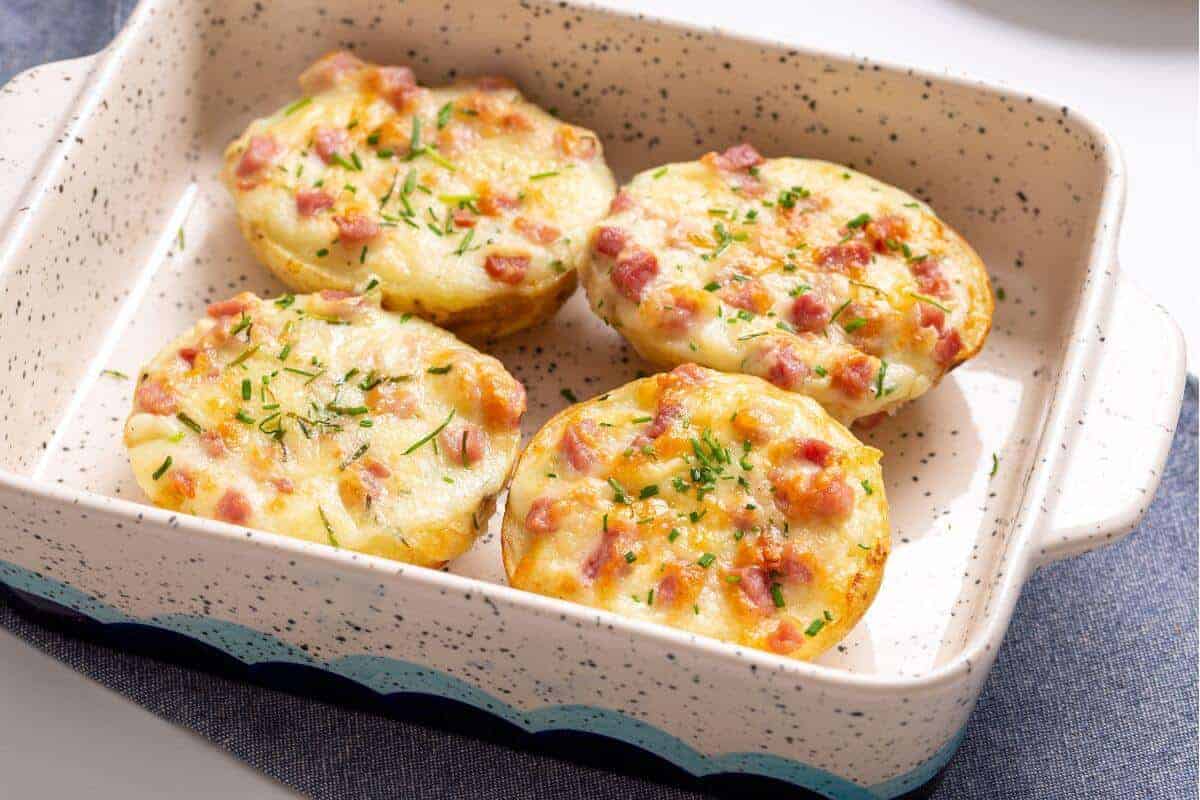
[580,145,994,423]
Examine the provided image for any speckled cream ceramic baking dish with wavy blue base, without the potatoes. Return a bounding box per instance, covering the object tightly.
[0,0,1184,798]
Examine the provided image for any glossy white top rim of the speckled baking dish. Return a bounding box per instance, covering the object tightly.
[0,0,1126,696]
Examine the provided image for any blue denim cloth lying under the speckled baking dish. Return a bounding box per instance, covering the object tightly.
[0,0,1198,800]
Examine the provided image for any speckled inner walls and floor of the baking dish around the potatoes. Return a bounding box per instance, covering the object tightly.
[0,0,1110,676]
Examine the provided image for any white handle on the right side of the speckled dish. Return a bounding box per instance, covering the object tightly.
[1036,277,1187,566]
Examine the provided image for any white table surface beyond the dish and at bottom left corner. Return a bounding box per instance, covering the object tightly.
[0,0,1200,800]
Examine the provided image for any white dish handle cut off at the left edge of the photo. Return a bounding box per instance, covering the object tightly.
[0,55,97,231]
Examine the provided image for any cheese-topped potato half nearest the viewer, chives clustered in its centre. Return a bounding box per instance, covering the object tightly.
[503,365,890,660]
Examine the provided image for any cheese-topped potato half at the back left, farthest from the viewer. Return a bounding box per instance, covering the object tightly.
[222,53,616,339]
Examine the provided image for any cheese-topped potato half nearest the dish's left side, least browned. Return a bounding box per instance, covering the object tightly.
[125,284,526,566]
